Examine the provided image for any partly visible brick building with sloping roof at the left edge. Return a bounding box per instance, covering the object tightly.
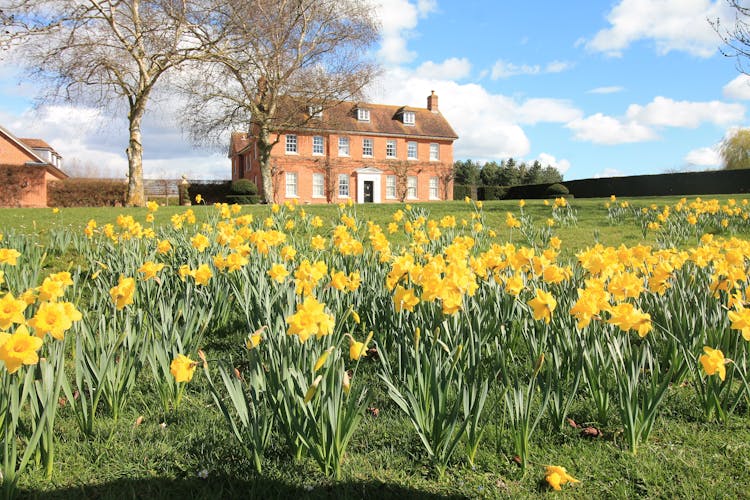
[0,127,68,207]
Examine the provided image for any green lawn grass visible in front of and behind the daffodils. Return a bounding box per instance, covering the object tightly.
[0,196,750,499]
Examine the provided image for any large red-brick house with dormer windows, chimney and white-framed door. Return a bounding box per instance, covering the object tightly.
[229,92,458,203]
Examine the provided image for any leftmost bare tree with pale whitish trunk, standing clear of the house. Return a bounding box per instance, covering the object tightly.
[0,0,207,206]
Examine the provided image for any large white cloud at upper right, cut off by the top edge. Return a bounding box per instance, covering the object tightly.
[586,0,733,57]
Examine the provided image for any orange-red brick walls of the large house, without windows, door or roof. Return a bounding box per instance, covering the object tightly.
[232,134,453,203]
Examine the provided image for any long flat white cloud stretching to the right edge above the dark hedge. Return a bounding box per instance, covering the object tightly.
[626,96,745,128]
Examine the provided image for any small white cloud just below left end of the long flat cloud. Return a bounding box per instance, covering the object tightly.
[565,113,657,145]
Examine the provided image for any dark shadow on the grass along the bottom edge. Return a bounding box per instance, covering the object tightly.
[19,475,464,500]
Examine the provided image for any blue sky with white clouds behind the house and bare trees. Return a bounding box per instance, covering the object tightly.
[0,0,750,180]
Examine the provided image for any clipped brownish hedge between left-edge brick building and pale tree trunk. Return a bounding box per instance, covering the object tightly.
[47,178,128,207]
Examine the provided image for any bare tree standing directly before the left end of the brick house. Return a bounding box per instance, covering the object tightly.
[184,0,378,202]
